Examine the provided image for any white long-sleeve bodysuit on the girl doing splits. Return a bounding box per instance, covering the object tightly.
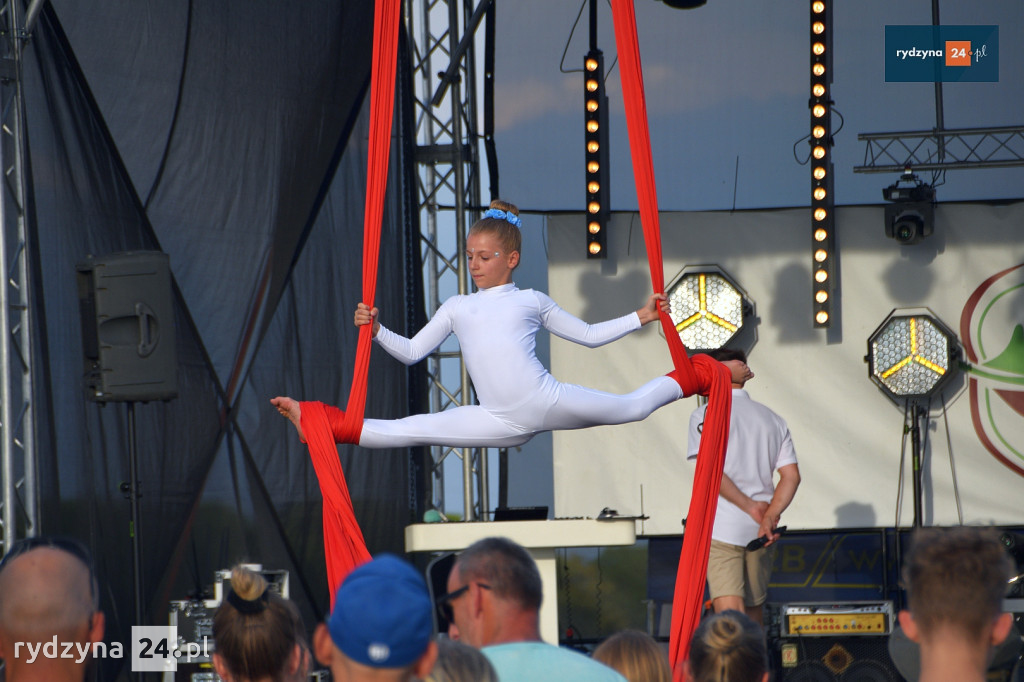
[359,284,683,447]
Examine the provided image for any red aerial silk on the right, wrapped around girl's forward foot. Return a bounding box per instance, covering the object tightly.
[611,0,732,680]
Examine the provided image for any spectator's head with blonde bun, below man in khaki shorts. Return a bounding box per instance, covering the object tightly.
[686,610,768,682]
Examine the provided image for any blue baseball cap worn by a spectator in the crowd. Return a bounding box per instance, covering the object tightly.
[327,554,434,668]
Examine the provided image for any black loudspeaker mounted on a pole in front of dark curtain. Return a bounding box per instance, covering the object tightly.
[77,251,178,402]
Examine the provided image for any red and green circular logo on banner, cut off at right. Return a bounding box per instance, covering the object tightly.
[961,263,1024,476]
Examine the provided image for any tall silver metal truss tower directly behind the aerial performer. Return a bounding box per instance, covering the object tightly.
[403,0,490,521]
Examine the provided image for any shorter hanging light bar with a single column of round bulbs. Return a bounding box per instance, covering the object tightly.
[583,49,608,258]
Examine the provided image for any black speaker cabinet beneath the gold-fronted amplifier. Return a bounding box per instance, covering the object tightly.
[774,635,903,682]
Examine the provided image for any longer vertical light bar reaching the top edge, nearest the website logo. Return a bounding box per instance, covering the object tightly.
[808,0,838,329]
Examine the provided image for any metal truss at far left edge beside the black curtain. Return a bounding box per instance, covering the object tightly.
[0,0,41,552]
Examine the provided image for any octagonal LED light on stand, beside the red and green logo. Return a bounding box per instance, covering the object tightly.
[865,308,962,402]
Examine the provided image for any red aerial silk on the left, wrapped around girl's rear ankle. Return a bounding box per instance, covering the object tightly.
[301,0,401,608]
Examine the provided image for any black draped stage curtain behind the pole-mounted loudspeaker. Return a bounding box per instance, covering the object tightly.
[23,0,424,679]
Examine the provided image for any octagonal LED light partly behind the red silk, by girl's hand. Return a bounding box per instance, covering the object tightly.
[666,265,752,351]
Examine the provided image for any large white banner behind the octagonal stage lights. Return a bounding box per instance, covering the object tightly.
[548,204,1024,535]
